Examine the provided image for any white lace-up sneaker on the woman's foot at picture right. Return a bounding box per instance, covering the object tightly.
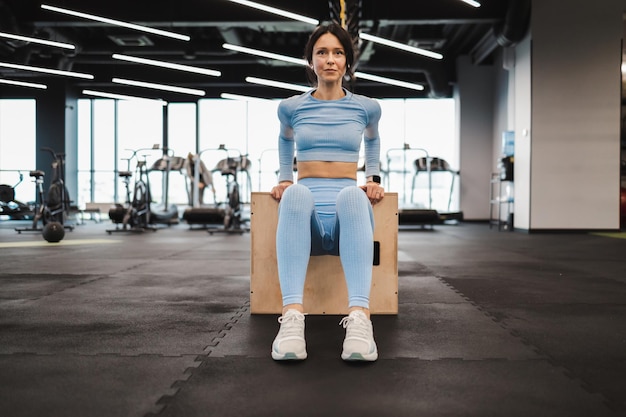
[339,310,378,361]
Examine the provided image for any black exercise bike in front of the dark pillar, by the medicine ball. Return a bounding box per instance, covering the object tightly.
[15,148,74,233]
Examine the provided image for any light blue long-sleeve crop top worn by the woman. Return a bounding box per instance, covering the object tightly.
[278,90,381,182]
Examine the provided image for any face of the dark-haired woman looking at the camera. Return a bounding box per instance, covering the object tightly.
[311,33,346,84]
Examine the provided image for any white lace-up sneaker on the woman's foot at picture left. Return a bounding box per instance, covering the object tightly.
[272,309,306,361]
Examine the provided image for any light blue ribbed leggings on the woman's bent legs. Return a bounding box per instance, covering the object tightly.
[276,178,374,308]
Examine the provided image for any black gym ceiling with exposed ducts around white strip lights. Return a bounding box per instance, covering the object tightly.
[0,0,530,102]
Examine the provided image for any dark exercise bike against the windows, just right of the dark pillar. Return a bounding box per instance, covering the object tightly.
[106,145,159,234]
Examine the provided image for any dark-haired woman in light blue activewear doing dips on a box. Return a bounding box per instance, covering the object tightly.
[271,23,384,361]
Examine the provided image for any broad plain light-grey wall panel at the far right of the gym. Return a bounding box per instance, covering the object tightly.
[530,0,623,229]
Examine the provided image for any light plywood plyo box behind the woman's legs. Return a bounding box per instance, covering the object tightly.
[250,192,398,315]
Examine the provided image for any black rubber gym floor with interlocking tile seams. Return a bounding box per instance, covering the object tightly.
[0,221,626,417]
